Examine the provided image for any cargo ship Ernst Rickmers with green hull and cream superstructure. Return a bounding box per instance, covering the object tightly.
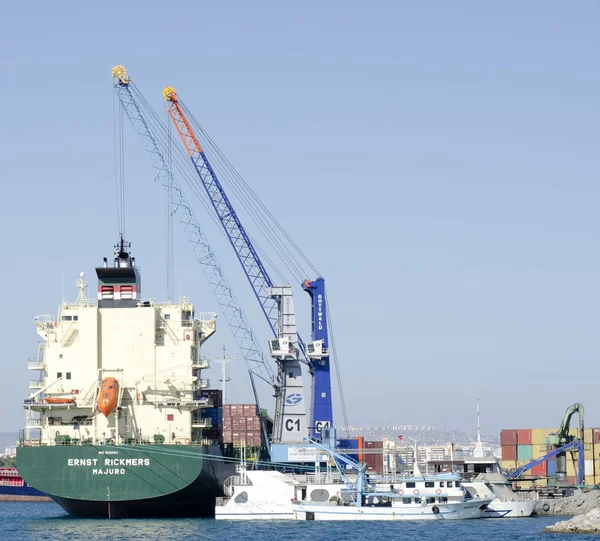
[17,237,234,518]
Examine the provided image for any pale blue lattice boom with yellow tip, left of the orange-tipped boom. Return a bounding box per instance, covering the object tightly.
[112,66,275,388]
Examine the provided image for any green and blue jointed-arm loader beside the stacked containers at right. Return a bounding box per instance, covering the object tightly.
[507,402,585,486]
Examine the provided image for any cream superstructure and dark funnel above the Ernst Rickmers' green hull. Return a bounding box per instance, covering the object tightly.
[25,239,216,445]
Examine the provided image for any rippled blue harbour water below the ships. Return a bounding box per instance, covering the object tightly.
[0,502,594,541]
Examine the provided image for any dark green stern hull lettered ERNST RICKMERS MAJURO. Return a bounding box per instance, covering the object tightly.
[17,445,234,518]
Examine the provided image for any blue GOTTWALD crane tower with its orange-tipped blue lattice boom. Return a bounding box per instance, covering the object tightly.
[163,86,333,438]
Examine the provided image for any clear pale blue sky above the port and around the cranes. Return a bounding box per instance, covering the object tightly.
[0,1,600,432]
